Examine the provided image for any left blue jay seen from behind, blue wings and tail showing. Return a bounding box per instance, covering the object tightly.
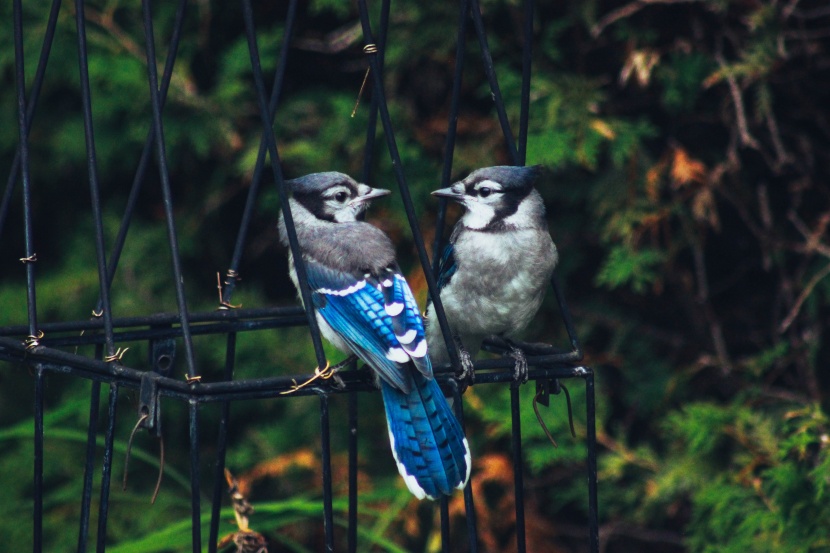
[280,172,471,499]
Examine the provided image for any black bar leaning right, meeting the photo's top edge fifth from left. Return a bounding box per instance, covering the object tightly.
[95,0,187,312]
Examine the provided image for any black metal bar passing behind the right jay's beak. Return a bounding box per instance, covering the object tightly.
[432,0,470,278]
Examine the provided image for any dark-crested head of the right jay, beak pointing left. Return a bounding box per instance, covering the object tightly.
[432,165,544,229]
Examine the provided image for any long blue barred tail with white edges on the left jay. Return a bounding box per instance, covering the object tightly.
[381,371,470,499]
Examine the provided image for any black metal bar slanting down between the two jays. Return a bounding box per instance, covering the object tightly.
[358,0,460,374]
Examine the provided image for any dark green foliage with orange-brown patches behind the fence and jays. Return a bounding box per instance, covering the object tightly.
[0,0,830,553]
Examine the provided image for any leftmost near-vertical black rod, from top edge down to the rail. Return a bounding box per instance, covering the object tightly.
[14,0,37,336]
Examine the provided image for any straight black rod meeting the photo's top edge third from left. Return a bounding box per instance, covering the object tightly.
[75,0,115,356]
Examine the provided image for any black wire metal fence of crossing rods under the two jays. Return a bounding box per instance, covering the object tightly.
[0,0,598,552]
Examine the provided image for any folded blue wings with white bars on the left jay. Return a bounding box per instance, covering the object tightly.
[306,260,432,393]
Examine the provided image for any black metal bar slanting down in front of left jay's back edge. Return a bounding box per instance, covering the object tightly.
[242,0,326,376]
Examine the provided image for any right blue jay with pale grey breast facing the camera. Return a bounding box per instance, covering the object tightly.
[426,166,558,381]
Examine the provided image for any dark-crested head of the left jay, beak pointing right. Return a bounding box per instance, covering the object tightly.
[286,171,390,223]
